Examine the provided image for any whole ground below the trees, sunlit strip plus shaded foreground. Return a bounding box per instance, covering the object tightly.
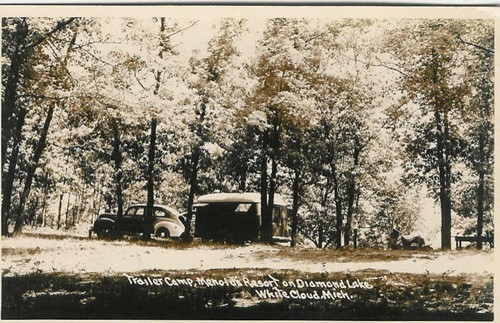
[2,230,495,320]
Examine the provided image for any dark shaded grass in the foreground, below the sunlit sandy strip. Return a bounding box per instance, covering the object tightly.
[2,269,493,320]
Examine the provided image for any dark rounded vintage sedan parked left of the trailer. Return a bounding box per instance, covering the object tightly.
[90,204,184,238]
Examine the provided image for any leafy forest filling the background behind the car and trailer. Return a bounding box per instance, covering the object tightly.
[2,12,494,248]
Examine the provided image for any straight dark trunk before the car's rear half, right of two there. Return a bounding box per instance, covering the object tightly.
[143,118,158,240]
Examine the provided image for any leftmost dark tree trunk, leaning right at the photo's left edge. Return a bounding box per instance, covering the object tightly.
[2,106,27,236]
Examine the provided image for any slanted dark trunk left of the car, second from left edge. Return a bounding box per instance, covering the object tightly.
[14,104,54,235]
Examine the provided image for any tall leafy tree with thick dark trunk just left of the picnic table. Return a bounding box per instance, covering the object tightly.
[390,20,468,249]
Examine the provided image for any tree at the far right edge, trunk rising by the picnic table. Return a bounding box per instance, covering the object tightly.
[455,21,494,249]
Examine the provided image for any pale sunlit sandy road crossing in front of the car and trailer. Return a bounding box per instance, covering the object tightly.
[2,236,495,276]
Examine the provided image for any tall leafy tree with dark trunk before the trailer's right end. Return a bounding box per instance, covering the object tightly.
[247,19,324,242]
